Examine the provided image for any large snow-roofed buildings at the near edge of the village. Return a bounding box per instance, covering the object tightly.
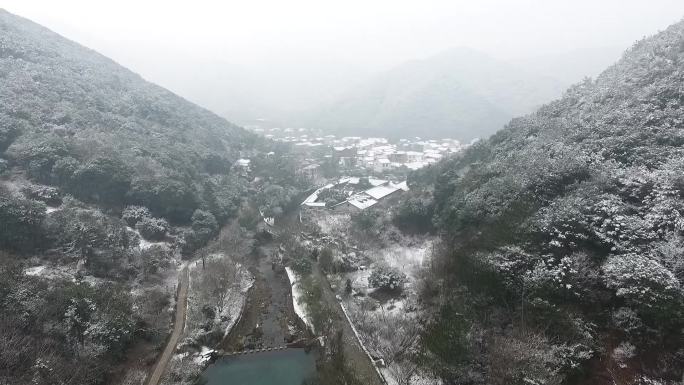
[301,177,408,211]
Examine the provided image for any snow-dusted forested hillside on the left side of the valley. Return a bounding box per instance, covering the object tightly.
[0,10,308,385]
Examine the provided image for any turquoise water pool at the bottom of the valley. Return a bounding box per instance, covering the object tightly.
[202,349,316,385]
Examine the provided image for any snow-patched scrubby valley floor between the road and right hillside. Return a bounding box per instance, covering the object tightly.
[306,210,439,385]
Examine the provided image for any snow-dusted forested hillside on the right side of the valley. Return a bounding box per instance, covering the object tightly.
[400,17,684,384]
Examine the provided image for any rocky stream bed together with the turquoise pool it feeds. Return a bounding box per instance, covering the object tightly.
[202,212,317,385]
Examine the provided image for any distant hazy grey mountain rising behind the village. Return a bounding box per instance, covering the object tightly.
[301,48,562,141]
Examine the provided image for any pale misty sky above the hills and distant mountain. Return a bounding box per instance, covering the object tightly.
[0,0,684,122]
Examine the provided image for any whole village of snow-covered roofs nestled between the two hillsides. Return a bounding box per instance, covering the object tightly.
[246,126,476,211]
